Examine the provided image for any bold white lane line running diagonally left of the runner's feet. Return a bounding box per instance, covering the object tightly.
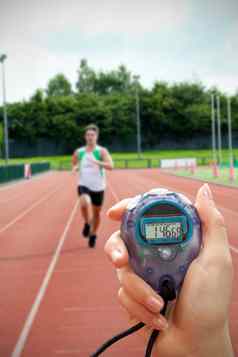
[11,200,79,357]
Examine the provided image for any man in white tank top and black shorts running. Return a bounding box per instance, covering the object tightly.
[72,124,113,248]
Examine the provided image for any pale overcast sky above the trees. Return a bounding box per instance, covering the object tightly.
[0,0,238,102]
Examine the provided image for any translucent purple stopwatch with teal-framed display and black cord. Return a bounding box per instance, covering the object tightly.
[92,189,201,357]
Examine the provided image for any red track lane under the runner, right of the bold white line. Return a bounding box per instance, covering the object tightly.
[19,172,144,357]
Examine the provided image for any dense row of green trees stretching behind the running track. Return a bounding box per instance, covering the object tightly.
[0,59,238,151]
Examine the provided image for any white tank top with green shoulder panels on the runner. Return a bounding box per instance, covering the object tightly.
[77,146,106,192]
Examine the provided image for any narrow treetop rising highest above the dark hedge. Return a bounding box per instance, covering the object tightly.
[76,59,96,93]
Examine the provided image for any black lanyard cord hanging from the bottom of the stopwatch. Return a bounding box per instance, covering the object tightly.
[90,284,175,357]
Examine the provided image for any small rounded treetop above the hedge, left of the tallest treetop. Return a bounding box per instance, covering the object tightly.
[46,73,72,97]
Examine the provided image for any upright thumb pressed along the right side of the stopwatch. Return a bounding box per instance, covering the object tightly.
[195,184,230,266]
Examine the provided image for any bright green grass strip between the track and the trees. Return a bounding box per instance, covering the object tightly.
[0,148,238,169]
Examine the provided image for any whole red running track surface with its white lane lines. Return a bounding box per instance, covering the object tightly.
[0,170,238,357]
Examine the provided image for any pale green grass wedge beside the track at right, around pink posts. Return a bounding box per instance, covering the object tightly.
[166,166,238,187]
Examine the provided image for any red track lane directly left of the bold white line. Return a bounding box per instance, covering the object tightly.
[0,174,75,357]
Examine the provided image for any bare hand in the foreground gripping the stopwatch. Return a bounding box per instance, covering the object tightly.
[105,184,233,357]
